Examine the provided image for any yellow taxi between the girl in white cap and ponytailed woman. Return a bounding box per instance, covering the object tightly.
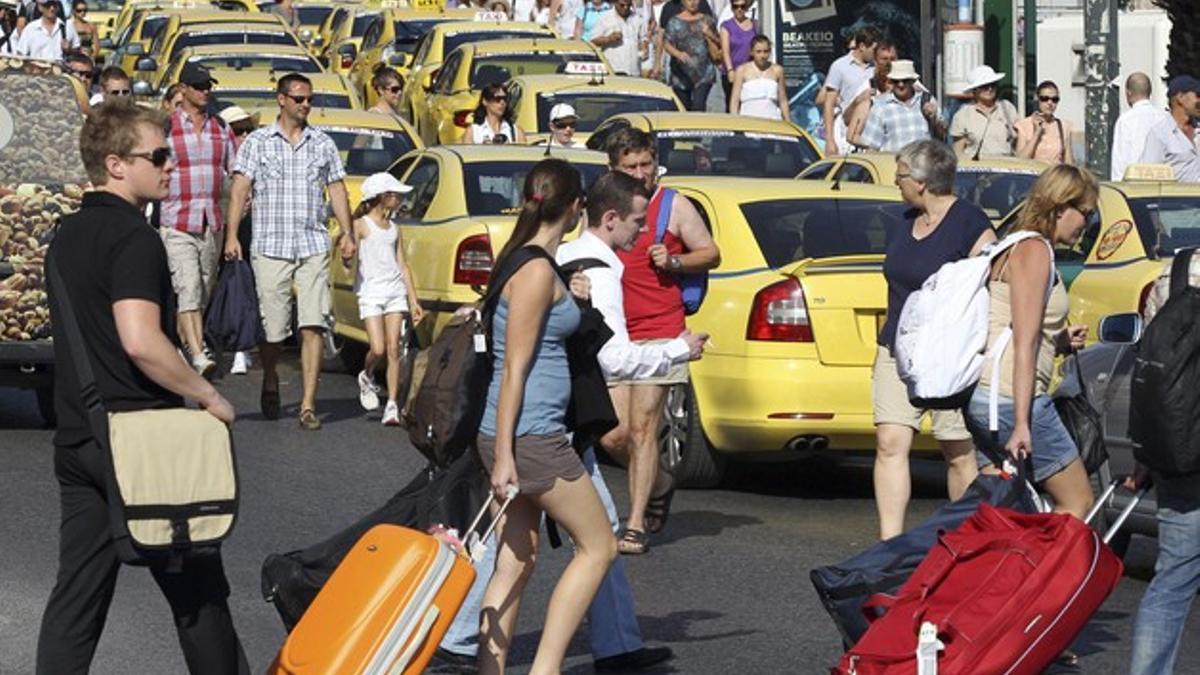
[334,145,607,346]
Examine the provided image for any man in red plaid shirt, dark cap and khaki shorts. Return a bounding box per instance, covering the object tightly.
[160,64,236,376]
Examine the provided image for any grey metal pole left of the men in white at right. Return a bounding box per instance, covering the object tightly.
[1084,0,1120,175]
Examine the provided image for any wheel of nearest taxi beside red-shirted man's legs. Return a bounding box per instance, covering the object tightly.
[659,384,726,488]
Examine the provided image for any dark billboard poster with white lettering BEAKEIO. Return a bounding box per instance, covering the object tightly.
[775,0,922,146]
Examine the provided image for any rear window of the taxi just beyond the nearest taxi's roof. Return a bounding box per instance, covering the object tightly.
[655,130,820,178]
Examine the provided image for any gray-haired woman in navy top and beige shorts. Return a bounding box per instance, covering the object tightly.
[871,141,996,539]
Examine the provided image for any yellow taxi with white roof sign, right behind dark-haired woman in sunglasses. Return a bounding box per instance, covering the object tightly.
[416,37,612,145]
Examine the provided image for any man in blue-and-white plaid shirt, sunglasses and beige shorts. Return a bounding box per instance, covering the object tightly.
[224,73,355,431]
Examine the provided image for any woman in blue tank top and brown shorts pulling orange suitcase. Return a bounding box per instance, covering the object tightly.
[478,159,617,675]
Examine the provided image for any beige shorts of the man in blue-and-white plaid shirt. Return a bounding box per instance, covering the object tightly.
[250,253,330,342]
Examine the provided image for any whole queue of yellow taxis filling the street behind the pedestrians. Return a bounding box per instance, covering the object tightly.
[9,0,1200,485]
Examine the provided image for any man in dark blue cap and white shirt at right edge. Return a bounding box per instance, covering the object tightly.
[1139,74,1200,183]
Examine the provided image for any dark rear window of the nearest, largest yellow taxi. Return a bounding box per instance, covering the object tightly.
[742,199,906,268]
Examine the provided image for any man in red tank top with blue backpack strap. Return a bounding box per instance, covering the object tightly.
[601,129,721,554]
